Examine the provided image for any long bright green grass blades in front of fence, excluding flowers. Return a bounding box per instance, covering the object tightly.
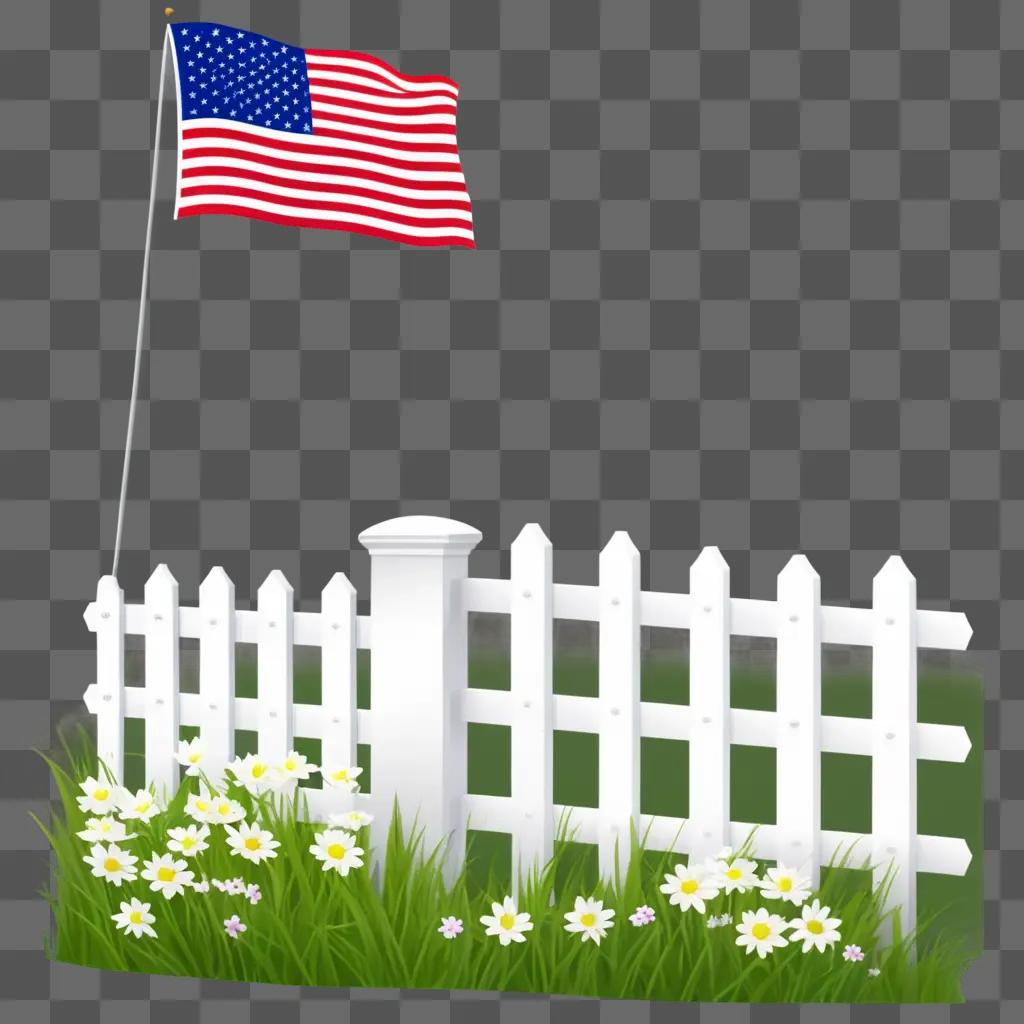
[41,729,969,1002]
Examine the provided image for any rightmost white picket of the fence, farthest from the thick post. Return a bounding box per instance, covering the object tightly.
[871,555,918,941]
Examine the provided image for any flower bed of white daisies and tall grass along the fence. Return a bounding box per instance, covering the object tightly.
[40,743,969,1002]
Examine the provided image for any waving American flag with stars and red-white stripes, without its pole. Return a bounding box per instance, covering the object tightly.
[170,22,474,248]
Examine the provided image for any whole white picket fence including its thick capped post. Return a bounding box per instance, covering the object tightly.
[85,516,971,942]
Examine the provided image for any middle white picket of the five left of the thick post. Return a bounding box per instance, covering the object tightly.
[199,565,236,782]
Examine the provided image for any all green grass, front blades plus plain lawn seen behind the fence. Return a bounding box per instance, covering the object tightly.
[50,651,984,1001]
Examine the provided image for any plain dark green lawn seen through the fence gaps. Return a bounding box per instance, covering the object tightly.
[119,651,984,951]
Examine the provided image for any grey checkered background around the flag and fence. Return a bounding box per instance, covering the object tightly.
[0,0,1024,1024]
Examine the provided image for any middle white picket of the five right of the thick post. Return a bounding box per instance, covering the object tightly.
[686,548,731,863]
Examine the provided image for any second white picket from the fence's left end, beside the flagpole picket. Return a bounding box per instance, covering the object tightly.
[145,564,180,799]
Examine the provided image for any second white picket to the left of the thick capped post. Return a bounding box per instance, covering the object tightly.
[256,569,294,762]
